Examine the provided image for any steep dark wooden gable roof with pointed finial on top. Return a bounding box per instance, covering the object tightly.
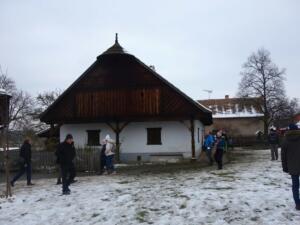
[40,36,212,124]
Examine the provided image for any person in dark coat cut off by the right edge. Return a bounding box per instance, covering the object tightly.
[281,124,300,210]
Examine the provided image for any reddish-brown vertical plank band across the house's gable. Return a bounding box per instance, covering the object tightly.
[75,88,160,118]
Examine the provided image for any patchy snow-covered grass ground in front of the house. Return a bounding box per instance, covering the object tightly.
[0,151,300,225]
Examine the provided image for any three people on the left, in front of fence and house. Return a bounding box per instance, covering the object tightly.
[10,134,116,195]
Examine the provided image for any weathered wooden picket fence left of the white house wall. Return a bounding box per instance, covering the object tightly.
[0,149,100,173]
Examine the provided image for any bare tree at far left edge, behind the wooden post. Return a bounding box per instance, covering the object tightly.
[0,68,33,130]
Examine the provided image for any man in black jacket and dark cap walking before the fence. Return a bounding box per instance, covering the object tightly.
[56,134,76,195]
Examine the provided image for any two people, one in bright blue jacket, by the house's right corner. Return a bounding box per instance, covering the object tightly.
[202,130,228,170]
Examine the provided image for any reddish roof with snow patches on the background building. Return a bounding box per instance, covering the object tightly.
[198,95,263,118]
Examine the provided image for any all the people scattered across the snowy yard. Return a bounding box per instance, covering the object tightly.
[10,124,300,210]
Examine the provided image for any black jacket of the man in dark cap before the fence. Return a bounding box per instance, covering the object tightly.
[55,142,76,166]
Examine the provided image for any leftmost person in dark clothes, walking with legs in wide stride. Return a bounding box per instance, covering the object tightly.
[10,139,33,187]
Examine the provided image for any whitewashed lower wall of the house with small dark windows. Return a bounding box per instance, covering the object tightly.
[60,121,203,161]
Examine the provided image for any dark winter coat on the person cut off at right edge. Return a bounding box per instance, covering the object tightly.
[281,130,300,175]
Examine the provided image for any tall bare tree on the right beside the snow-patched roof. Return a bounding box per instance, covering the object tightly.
[238,48,286,135]
